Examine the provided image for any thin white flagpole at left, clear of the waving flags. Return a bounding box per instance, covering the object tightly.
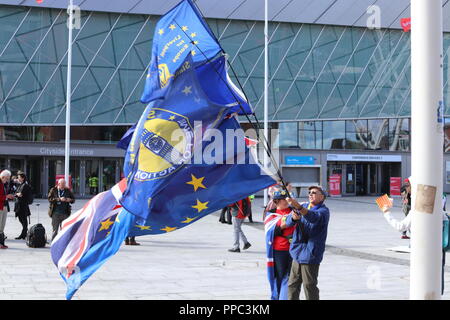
[64,0,73,186]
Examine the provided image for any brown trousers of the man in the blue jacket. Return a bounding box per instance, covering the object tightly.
[288,260,320,300]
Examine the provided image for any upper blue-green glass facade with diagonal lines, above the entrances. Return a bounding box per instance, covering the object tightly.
[0,6,450,126]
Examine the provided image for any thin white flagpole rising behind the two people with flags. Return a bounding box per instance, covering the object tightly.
[264,0,270,206]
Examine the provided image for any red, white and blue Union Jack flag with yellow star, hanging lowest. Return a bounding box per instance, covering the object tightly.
[51,179,134,299]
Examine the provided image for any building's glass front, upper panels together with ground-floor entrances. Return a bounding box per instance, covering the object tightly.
[0,5,450,196]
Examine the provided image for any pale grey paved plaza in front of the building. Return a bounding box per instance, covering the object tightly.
[0,197,450,300]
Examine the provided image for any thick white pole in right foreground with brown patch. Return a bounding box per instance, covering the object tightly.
[410,0,444,300]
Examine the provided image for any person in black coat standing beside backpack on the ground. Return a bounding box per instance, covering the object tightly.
[14,173,32,240]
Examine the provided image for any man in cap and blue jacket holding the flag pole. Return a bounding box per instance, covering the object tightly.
[286,186,330,300]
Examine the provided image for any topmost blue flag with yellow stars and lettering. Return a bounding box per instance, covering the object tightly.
[141,0,222,103]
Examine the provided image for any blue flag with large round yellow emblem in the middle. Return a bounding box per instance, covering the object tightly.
[121,55,233,222]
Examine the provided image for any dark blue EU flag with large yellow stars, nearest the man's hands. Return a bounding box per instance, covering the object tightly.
[125,117,276,236]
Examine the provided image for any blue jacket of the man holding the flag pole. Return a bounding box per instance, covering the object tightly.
[286,203,330,264]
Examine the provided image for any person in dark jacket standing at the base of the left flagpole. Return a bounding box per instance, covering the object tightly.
[48,179,75,240]
